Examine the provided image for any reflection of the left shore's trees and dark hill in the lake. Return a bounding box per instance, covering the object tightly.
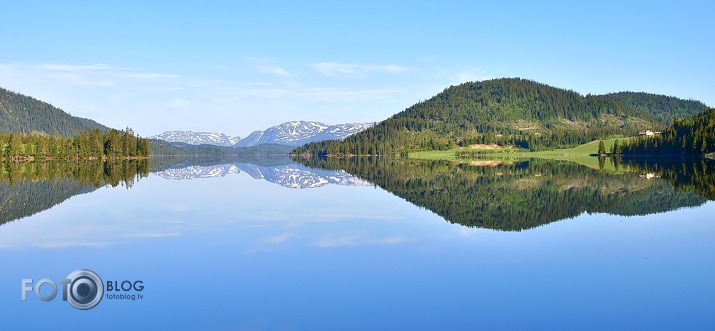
[0,159,149,224]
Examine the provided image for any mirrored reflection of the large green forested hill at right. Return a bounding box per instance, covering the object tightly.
[300,158,714,230]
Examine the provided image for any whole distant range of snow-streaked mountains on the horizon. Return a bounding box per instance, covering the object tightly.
[150,121,373,147]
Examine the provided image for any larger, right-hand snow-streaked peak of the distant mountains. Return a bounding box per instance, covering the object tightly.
[235,121,374,147]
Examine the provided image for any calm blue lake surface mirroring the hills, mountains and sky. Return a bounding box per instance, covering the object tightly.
[0,159,715,330]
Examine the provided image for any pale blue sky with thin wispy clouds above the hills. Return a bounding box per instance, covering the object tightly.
[0,0,715,137]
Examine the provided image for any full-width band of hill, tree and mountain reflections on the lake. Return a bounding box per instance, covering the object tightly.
[0,157,715,231]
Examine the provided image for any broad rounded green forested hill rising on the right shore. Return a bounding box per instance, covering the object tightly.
[295,78,707,155]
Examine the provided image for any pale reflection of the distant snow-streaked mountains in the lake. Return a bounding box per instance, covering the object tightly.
[156,160,372,189]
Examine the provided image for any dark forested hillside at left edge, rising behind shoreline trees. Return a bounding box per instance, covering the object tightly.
[0,88,107,137]
